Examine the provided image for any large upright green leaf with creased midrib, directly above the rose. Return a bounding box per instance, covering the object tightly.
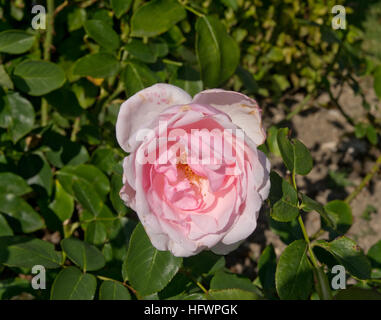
[196,16,240,88]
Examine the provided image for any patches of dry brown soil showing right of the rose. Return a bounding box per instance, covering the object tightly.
[226,79,381,279]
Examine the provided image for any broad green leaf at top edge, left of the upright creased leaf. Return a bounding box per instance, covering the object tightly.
[131,0,186,37]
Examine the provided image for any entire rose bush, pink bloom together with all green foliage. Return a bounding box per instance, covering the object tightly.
[0,0,381,304]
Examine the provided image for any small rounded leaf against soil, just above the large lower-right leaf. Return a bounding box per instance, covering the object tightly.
[324,200,353,234]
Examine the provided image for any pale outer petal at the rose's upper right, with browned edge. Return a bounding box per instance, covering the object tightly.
[192,89,266,145]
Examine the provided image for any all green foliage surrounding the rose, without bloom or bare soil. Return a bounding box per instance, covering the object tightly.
[0,0,381,300]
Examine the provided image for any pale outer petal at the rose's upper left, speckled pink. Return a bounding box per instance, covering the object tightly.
[116,83,192,152]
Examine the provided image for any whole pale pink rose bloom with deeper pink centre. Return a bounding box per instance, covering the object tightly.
[116,84,270,257]
